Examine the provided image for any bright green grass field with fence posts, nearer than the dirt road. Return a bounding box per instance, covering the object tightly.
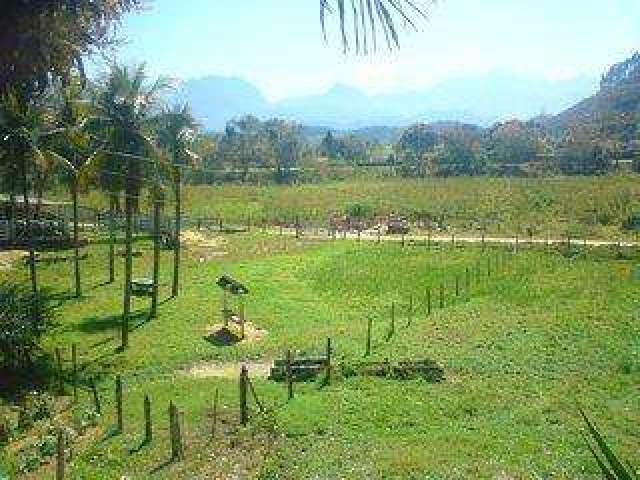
[3,227,640,479]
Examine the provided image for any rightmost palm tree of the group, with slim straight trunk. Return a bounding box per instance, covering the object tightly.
[157,105,199,297]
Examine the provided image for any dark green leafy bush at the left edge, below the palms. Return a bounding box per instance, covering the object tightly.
[0,281,54,370]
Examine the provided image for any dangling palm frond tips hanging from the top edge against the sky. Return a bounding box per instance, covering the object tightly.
[319,0,432,55]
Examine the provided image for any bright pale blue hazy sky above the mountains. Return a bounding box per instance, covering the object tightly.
[115,0,640,100]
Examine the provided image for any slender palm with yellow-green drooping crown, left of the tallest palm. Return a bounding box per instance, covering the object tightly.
[48,82,97,298]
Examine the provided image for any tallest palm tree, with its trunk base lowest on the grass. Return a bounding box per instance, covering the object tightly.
[95,65,169,349]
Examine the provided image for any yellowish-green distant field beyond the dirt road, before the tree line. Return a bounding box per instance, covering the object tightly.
[62,175,640,239]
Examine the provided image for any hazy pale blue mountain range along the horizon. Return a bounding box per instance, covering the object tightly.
[178,72,598,131]
